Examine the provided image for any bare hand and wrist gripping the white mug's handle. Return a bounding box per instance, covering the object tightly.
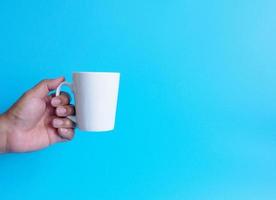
[0,77,75,153]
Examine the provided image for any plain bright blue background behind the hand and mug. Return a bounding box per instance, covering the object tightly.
[0,0,276,200]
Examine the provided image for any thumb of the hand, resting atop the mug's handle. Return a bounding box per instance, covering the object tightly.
[30,77,64,98]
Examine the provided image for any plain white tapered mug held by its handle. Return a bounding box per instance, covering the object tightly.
[56,72,120,131]
